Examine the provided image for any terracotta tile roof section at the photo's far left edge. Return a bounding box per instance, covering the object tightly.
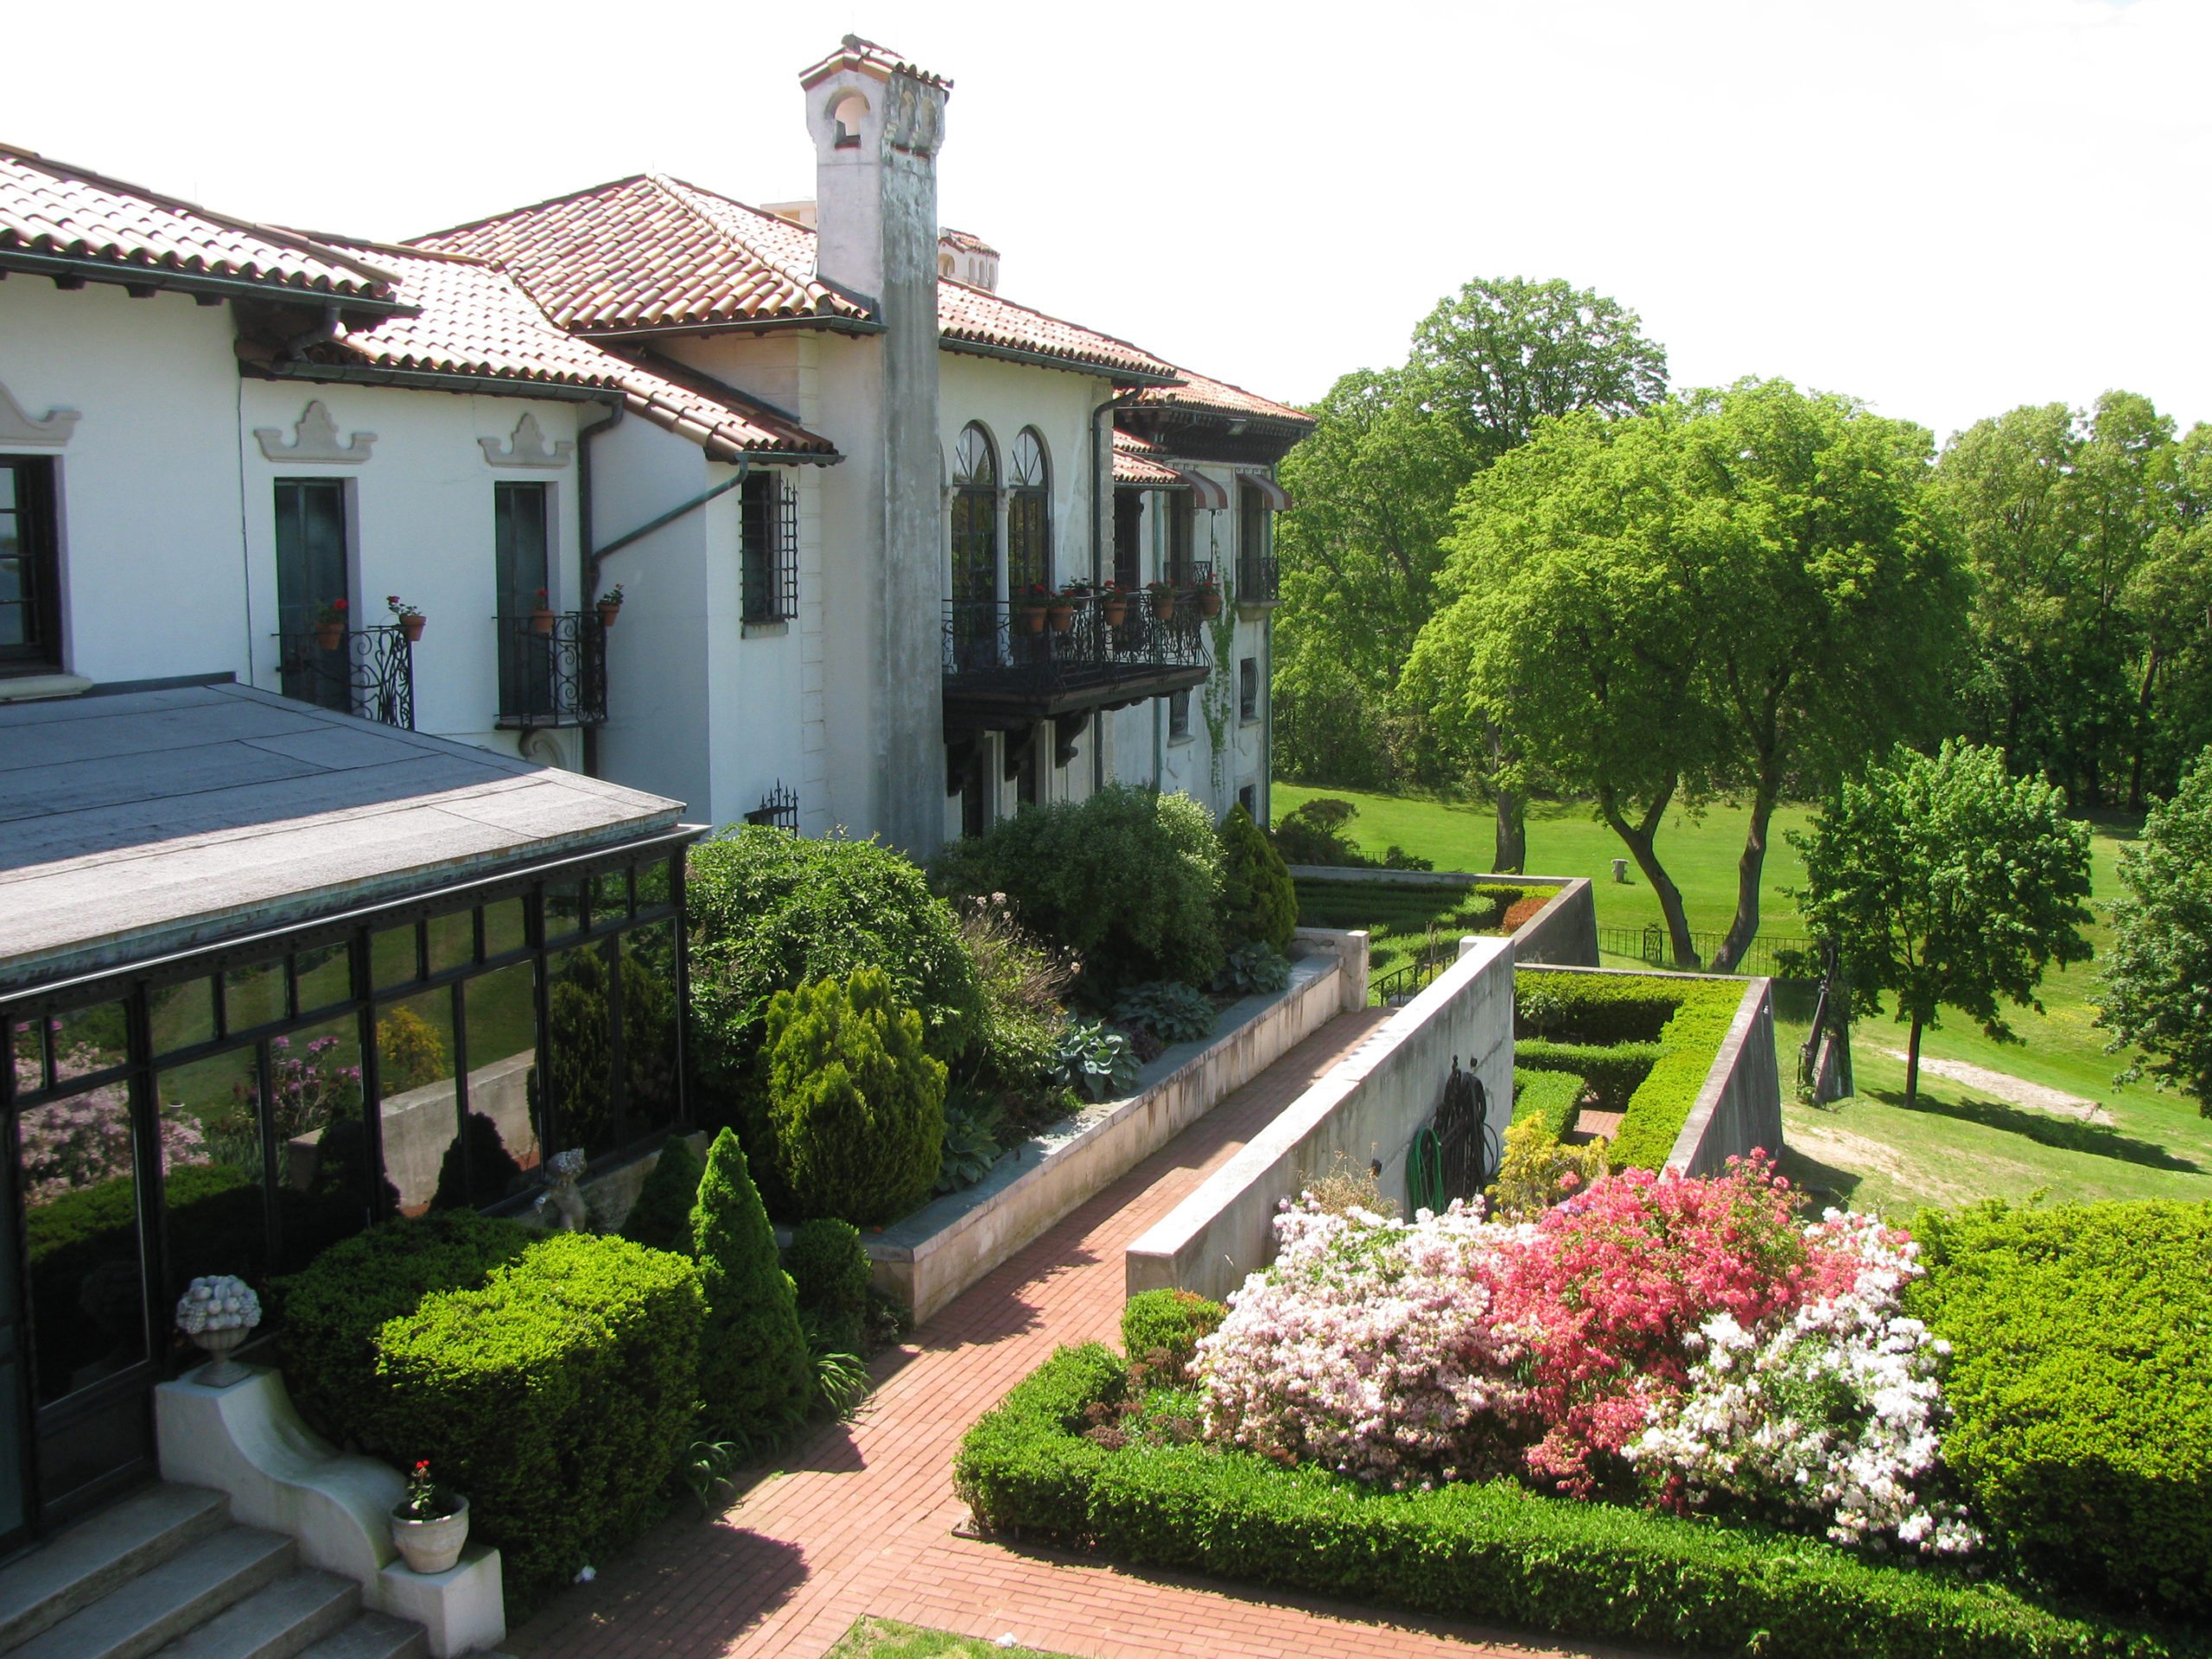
[0,143,391,305]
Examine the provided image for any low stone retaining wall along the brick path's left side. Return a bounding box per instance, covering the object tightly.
[865,951,1344,1319]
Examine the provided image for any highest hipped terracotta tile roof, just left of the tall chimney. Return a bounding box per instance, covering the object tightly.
[410,173,868,336]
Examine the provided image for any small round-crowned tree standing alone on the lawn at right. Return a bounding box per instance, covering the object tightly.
[1789,741,2090,1106]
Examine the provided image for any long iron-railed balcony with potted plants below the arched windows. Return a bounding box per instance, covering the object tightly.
[944,591,1205,732]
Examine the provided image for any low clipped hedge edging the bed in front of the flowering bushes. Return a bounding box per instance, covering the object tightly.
[953,1343,2203,1659]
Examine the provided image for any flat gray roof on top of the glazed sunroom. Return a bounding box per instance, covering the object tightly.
[0,686,681,987]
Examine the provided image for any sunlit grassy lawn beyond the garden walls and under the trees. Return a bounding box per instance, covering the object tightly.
[1274,783,2212,1219]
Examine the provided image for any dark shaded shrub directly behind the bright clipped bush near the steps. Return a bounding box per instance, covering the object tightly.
[272,1210,537,1451]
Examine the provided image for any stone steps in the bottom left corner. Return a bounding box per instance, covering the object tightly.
[0,1484,429,1659]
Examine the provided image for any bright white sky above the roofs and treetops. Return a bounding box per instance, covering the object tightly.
[21,0,2212,434]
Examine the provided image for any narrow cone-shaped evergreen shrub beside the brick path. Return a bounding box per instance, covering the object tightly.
[692,1128,814,1442]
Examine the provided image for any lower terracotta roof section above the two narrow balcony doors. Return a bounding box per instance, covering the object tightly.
[267,245,836,460]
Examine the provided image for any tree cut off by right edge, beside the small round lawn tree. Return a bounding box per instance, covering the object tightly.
[2097,750,2212,1117]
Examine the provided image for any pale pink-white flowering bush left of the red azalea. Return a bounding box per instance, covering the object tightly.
[1197,1201,1520,1489]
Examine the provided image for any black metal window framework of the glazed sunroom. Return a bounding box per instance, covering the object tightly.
[0,830,699,1524]
